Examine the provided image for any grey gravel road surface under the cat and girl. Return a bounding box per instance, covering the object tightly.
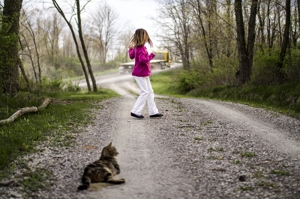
[0,84,300,199]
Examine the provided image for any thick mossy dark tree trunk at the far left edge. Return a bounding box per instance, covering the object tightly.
[0,0,22,94]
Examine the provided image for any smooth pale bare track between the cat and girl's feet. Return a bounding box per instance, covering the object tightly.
[88,96,193,199]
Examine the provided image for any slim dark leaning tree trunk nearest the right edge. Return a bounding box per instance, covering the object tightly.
[276,0,291,83]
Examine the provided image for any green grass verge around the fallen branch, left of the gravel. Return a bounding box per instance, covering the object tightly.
[0,89,118,173]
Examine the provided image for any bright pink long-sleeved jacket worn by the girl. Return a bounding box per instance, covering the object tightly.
[128,46,155,77]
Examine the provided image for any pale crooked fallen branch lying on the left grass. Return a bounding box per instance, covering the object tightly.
[0,98,51,125]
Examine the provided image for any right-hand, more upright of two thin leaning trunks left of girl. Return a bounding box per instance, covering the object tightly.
[76,0,97,92]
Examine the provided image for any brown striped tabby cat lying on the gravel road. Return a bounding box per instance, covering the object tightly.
[78,142,125,191]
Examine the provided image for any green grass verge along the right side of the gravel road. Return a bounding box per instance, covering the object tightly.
[151,69,300,119]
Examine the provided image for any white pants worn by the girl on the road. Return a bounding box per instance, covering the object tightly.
[131,76,158,115]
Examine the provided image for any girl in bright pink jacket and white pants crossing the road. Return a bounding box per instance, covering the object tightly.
[128,29,163,118]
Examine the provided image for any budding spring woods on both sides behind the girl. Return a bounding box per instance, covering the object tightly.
[0,0,300,94]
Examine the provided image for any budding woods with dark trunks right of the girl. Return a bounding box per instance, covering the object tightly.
[157,0,300,92]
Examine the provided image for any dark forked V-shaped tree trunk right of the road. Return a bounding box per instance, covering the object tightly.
[234,0,258,85]
